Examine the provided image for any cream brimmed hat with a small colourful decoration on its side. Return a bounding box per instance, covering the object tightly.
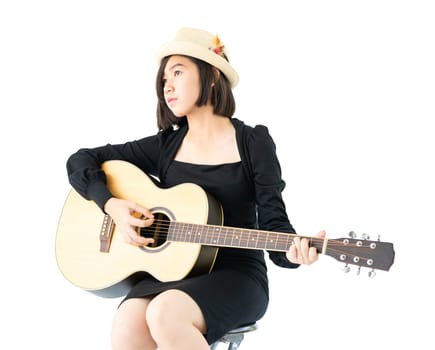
[157,27,239,88]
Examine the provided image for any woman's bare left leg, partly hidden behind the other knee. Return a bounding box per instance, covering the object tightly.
[112,298,157,350]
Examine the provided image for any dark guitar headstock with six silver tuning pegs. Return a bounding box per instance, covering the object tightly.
[325,231,395,277]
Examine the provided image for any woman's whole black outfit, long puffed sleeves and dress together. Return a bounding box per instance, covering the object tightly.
[67,118,298,343]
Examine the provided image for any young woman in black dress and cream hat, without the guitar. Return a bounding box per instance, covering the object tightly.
[67,28,325,350]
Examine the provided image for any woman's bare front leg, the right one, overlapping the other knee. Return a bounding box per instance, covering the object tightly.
[146,289,210,350]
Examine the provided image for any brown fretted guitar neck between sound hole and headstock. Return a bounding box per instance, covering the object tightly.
[168,221,325,253]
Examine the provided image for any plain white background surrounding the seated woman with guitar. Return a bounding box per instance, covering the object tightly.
[0,0,435,350]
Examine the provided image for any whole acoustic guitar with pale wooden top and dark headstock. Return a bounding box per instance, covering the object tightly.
[55,160,395,297]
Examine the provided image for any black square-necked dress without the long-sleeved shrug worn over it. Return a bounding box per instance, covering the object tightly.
[124,161,269,343]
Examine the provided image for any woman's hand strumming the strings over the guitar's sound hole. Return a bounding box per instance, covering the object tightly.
[104,197,154,246]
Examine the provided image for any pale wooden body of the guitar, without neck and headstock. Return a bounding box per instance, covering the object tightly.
[55,160,223,297]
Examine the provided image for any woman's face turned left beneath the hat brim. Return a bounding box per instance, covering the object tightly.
[163,56,201,117]
